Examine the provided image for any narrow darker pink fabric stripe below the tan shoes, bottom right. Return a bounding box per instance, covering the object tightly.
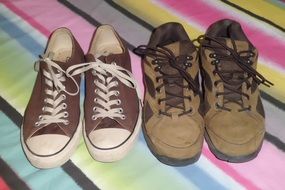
[203,145,260,190]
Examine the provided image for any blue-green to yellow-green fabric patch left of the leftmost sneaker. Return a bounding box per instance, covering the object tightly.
[0,29,37,113]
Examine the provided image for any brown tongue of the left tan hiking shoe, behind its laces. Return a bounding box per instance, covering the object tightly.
[161,41,195,113]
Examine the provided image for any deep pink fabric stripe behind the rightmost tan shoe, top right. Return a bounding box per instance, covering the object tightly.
[159,0,285,68]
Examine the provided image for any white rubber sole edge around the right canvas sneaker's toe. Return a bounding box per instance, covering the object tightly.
[83,103,142,162]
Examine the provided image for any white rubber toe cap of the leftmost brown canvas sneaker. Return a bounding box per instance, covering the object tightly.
[26,134,70,156]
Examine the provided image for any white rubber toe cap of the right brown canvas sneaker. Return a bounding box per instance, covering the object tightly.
[89,128,131,149]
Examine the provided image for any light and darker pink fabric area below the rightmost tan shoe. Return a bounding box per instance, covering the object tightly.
[203,141,285,189]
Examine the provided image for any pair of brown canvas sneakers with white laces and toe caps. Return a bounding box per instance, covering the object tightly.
[21,25,142,168]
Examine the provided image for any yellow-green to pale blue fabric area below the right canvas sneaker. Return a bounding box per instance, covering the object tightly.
[71,141,198,190]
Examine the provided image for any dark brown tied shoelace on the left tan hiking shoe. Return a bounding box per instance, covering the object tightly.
[134,45,199,116]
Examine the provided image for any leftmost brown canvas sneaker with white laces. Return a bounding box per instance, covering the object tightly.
[21,28,84,168]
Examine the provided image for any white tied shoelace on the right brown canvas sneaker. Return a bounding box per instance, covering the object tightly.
[67,59,140,120]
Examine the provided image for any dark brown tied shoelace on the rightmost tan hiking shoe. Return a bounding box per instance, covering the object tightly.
[197,35,273,111]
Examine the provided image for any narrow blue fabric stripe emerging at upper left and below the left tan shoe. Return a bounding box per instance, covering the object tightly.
[0,10,225,190]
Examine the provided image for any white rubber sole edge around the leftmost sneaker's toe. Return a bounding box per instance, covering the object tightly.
[21,121,82,169]
